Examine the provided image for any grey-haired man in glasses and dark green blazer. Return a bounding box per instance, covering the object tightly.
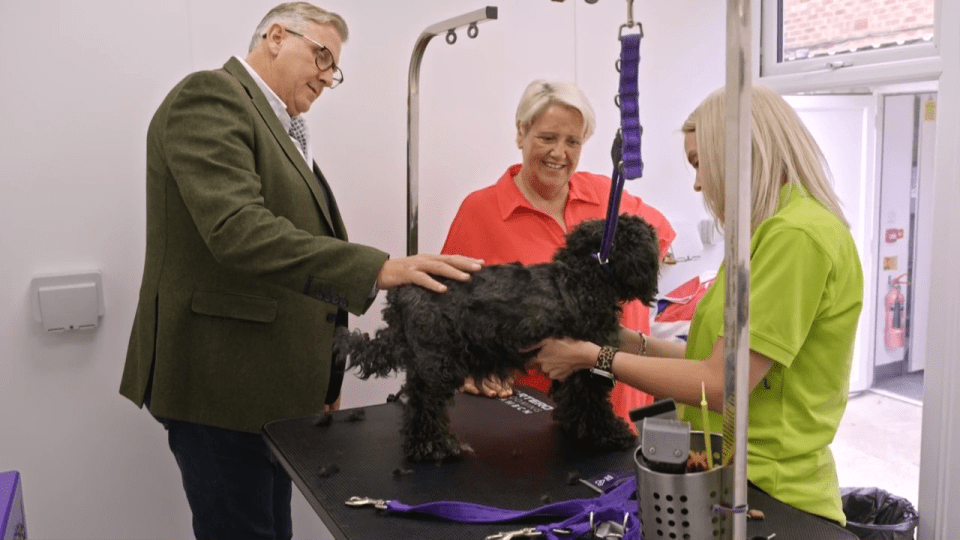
[120,2,480,538]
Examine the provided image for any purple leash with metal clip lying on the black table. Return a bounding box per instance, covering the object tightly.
[347,476,640,540]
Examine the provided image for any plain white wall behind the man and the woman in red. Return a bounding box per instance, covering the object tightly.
[0,0,725,539]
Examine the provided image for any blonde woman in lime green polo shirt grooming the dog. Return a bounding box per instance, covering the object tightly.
[537,87,863,524]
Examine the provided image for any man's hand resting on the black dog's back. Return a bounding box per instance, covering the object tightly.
[377,254,483,293]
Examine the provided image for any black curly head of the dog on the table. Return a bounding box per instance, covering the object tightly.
[554,214,660,305]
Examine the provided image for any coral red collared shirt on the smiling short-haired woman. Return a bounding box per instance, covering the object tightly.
[442,164,676,418]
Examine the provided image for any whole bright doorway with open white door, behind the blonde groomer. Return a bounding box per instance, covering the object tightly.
[787,87,936,510]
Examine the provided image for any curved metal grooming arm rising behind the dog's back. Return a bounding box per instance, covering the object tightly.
[407,6,497,255]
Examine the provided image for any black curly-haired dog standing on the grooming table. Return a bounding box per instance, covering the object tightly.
[336,214,659,461]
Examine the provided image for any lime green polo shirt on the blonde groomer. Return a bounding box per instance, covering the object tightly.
[683,186,863,523]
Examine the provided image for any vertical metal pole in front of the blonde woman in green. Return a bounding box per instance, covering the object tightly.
[723,0,752,540]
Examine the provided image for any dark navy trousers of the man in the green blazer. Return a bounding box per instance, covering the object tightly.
[160,418,293,540]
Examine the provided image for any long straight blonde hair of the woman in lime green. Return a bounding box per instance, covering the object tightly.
[681,86,850,231]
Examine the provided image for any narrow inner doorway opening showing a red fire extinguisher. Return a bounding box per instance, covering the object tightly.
[871,92,937,402]
